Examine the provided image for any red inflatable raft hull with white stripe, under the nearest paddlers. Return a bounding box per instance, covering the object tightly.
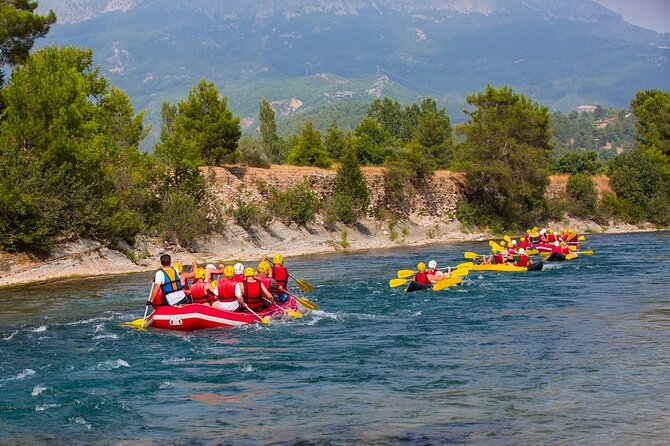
[144,297,298,331]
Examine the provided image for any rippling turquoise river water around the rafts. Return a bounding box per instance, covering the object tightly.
[0,233,670,445]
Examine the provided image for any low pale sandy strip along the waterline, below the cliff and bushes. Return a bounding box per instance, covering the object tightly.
[0,219,655,286]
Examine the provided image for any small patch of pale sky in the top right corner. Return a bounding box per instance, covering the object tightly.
[595,0,670,33]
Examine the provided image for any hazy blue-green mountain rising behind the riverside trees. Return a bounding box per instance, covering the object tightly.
[40,0,670,136]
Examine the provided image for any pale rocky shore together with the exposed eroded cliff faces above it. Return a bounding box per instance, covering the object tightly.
[0,166,654,287]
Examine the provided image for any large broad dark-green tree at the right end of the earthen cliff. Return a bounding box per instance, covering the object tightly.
[458,85,552,228]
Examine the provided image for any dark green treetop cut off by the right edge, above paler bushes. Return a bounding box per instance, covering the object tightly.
[631,90,670,157]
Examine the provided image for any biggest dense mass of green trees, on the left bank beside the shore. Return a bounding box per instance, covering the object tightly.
[0,47,153,250]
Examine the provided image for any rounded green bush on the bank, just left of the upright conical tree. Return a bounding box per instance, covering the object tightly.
[268,177,319,225]
